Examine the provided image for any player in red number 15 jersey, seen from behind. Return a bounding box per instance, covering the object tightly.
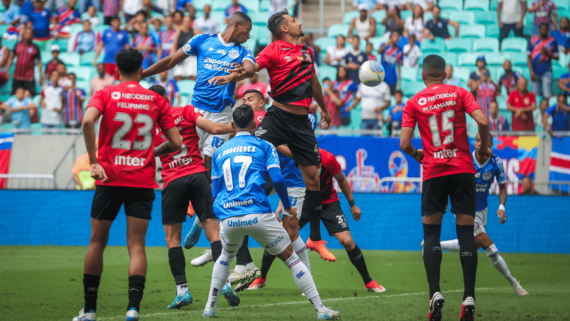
[400,55,492,321]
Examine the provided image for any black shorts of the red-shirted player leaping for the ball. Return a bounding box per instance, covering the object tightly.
[255,106,321,166]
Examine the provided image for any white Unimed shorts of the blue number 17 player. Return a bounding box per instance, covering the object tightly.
[220,213,291,255]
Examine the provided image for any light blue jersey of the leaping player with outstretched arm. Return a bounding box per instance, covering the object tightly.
[183,34,255,113]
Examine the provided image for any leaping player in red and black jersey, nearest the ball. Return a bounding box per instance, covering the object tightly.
[255,9,334,260]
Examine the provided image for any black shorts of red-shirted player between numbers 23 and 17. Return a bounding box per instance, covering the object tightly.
[162,172,217,225]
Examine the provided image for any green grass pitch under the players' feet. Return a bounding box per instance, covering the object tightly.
[0,245,570,321]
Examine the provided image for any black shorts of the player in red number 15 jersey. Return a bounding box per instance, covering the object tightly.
[422,173,477,216]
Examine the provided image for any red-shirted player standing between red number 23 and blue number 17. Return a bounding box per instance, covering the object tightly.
[149,85,233,309]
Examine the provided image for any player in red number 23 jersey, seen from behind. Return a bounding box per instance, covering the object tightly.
[73,49,182,321]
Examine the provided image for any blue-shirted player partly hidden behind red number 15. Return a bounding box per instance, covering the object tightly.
[438,134,528,295]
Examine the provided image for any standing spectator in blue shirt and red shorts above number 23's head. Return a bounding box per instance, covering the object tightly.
[93,16,129,80]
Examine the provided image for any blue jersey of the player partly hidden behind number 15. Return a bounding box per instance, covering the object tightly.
[472,152,507,211]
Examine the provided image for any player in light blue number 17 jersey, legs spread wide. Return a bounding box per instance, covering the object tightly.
[203,105,340,320]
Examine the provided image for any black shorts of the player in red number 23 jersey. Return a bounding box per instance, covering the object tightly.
[91,186,155,221]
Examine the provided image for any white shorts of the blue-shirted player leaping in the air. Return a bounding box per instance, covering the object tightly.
[196,106,232,157]
